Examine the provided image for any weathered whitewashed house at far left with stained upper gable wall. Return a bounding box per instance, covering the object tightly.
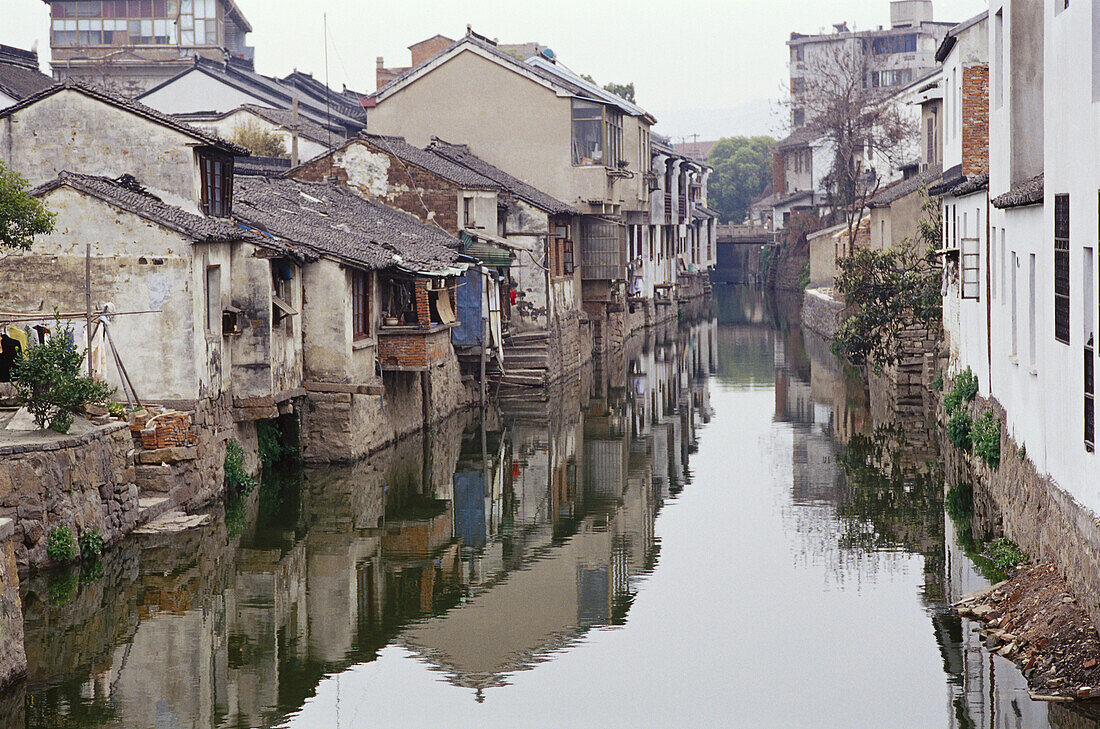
[0,80,303,498]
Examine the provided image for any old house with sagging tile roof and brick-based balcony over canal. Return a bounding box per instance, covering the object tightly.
[233,176,469,462]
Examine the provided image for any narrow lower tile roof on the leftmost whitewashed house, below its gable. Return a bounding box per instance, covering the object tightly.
[32,172,260,247]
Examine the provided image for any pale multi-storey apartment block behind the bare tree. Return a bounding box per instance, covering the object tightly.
[787,0,955,129]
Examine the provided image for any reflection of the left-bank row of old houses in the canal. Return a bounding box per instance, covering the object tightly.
[15,322,721,729]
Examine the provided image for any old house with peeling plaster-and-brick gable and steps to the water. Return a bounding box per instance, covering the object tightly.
[289,134,589,382]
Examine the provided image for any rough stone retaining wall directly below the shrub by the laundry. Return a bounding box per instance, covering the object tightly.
[0,423,138,570]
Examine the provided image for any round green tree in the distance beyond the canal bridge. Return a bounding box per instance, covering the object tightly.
[706,136,774,223]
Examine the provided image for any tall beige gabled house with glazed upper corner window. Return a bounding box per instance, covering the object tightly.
[364,32,655,358]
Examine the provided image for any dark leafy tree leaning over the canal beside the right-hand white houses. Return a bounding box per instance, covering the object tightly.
[833,194,943,367]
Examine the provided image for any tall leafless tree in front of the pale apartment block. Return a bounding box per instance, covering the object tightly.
[799,38,919,250]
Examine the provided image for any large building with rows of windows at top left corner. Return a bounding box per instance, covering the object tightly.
[44,0,253,97]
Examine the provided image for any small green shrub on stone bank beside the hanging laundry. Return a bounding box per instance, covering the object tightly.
[13,318,114,433]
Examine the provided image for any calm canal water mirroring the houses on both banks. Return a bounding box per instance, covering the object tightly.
[0,287,1097,729]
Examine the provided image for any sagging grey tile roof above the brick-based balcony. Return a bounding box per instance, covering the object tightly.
[233,177,460,275]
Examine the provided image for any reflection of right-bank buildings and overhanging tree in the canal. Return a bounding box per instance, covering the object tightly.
[734,287,1100,729]
